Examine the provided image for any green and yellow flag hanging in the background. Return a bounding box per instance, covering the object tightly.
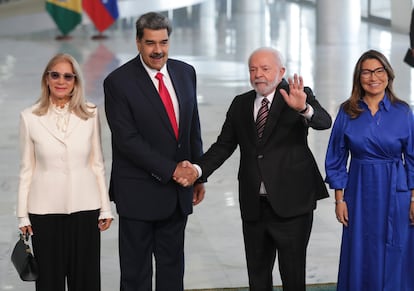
[46,0,82,35]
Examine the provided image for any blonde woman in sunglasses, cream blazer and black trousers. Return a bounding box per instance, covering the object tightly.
[17,54,113,291]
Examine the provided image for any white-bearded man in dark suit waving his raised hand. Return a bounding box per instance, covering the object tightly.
[183,48,331,291]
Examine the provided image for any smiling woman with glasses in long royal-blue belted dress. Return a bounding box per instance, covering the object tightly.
[325,50,414,291]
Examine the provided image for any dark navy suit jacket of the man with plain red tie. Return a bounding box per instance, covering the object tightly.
[104,55,202,221]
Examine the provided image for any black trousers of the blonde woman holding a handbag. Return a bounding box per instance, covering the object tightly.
[29,210,101,291]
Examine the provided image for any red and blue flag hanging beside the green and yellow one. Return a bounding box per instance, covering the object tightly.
[82,0,119,32]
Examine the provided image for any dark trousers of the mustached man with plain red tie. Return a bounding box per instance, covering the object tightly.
[119,207,187,291]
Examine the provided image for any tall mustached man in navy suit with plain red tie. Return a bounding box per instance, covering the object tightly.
[104,12,204,291]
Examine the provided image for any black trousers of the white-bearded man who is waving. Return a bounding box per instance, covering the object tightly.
[243,198,313,291]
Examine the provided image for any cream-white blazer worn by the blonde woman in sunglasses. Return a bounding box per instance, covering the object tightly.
[17,105,113,227]
